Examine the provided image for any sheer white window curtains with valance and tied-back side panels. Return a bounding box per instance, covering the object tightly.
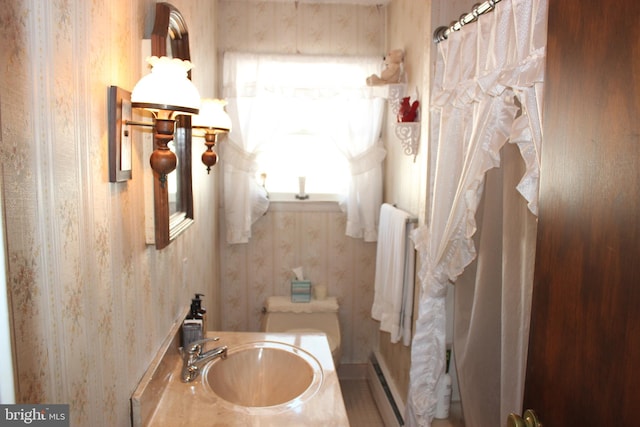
[220,52,386,243]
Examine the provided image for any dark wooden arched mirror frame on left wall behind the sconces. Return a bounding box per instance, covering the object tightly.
[151,3,193,249]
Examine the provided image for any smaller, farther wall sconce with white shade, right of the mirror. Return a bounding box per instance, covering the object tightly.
[191,99,231,173]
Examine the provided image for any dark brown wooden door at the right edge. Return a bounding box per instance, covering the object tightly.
[524,0,640,427]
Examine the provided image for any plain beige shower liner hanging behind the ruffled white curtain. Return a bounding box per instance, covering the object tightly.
[453,144,537,427]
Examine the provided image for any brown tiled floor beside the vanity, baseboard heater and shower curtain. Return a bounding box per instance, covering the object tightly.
[340,379,464,427]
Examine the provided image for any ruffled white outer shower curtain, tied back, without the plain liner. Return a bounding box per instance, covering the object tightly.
[406,0,547,426]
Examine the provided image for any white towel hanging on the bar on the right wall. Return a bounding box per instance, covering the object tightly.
[371,203,415,345]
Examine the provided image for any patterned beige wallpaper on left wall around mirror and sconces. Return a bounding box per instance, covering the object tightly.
[0,0,218,427]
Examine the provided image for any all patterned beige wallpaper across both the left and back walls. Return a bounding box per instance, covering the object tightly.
[0,0,442,426]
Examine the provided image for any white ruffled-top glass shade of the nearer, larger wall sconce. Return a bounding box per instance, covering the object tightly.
[131,56,200,114]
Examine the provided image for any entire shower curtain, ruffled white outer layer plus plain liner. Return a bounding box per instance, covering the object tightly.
[405,0,547,427]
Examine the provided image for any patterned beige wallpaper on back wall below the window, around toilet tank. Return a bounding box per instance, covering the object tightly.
[221,203,377,363]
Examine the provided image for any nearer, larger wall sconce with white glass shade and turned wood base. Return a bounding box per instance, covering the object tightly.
[109,56,200,185]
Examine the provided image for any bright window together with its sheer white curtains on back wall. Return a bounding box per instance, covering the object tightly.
[221,52,386,243]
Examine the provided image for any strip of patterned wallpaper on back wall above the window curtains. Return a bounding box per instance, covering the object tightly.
[217,0,386,56]
